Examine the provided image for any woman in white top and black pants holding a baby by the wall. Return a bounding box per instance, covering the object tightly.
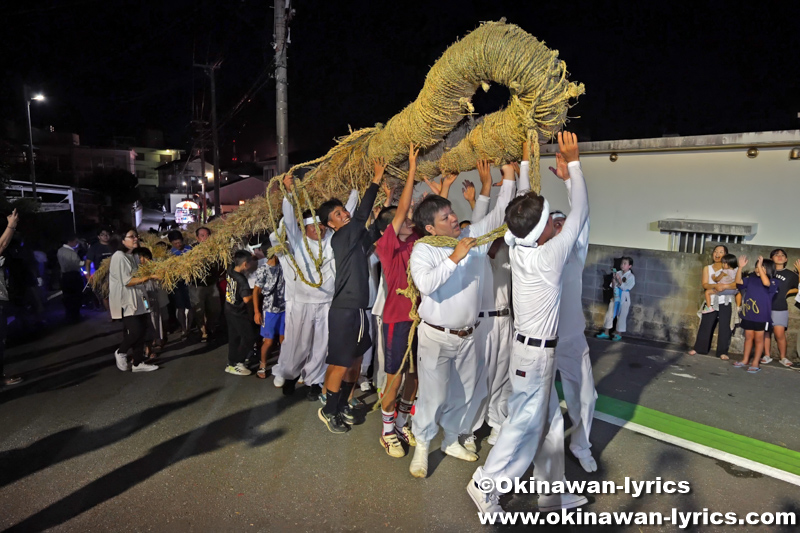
[689,244,736,360]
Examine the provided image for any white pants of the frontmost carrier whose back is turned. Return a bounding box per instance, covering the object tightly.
[472,341,564,483]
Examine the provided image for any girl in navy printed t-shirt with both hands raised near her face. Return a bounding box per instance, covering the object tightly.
[733,255,778,374]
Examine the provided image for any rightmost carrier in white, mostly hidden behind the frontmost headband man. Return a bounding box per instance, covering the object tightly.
[550,171,597,472]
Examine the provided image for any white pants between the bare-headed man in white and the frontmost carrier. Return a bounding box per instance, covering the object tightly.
[461,315,514,434]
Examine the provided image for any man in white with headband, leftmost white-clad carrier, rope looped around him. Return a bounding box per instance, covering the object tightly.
[272,174,358,401]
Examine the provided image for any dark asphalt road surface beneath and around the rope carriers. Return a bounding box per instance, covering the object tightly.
[0,314,800,532]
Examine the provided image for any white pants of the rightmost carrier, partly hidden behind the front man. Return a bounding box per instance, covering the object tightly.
[556,332,597,458]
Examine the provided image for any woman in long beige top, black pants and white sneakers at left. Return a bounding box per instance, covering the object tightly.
[108,228,158,372]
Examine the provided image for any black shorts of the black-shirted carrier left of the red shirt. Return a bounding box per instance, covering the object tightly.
[325,307,372,367]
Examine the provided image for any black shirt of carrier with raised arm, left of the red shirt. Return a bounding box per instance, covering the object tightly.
[331,183,378,309]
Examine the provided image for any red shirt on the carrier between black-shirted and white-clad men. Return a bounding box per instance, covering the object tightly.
[375,224,419,324]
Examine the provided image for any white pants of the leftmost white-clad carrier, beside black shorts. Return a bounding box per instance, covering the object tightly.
[272,300,331,386]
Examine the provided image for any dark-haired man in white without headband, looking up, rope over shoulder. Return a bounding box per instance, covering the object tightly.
[409,161,516,477]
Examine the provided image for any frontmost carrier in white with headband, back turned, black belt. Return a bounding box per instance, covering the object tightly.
[467,132,589,512]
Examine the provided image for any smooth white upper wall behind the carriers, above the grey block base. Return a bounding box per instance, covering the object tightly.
[440,147,800,250]
